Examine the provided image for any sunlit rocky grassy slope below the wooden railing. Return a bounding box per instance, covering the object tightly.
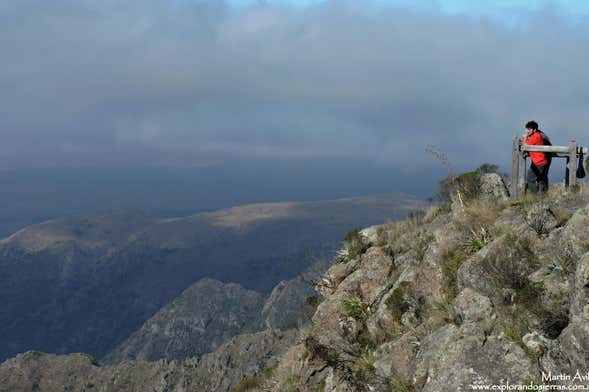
[256,179,589,392]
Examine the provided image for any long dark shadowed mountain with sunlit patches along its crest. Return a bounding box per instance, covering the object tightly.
[0,194,423,360]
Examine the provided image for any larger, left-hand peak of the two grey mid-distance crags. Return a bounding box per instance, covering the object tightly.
[105,279,264,363]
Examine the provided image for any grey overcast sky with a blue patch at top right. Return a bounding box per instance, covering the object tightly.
[0,0,589,170]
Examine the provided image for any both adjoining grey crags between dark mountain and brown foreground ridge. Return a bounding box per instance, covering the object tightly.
[100,262,327,363]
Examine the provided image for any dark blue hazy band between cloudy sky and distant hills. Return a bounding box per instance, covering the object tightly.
[0,158,435,238]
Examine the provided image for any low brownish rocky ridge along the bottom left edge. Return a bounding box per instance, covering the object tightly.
[0,330,296,392]
